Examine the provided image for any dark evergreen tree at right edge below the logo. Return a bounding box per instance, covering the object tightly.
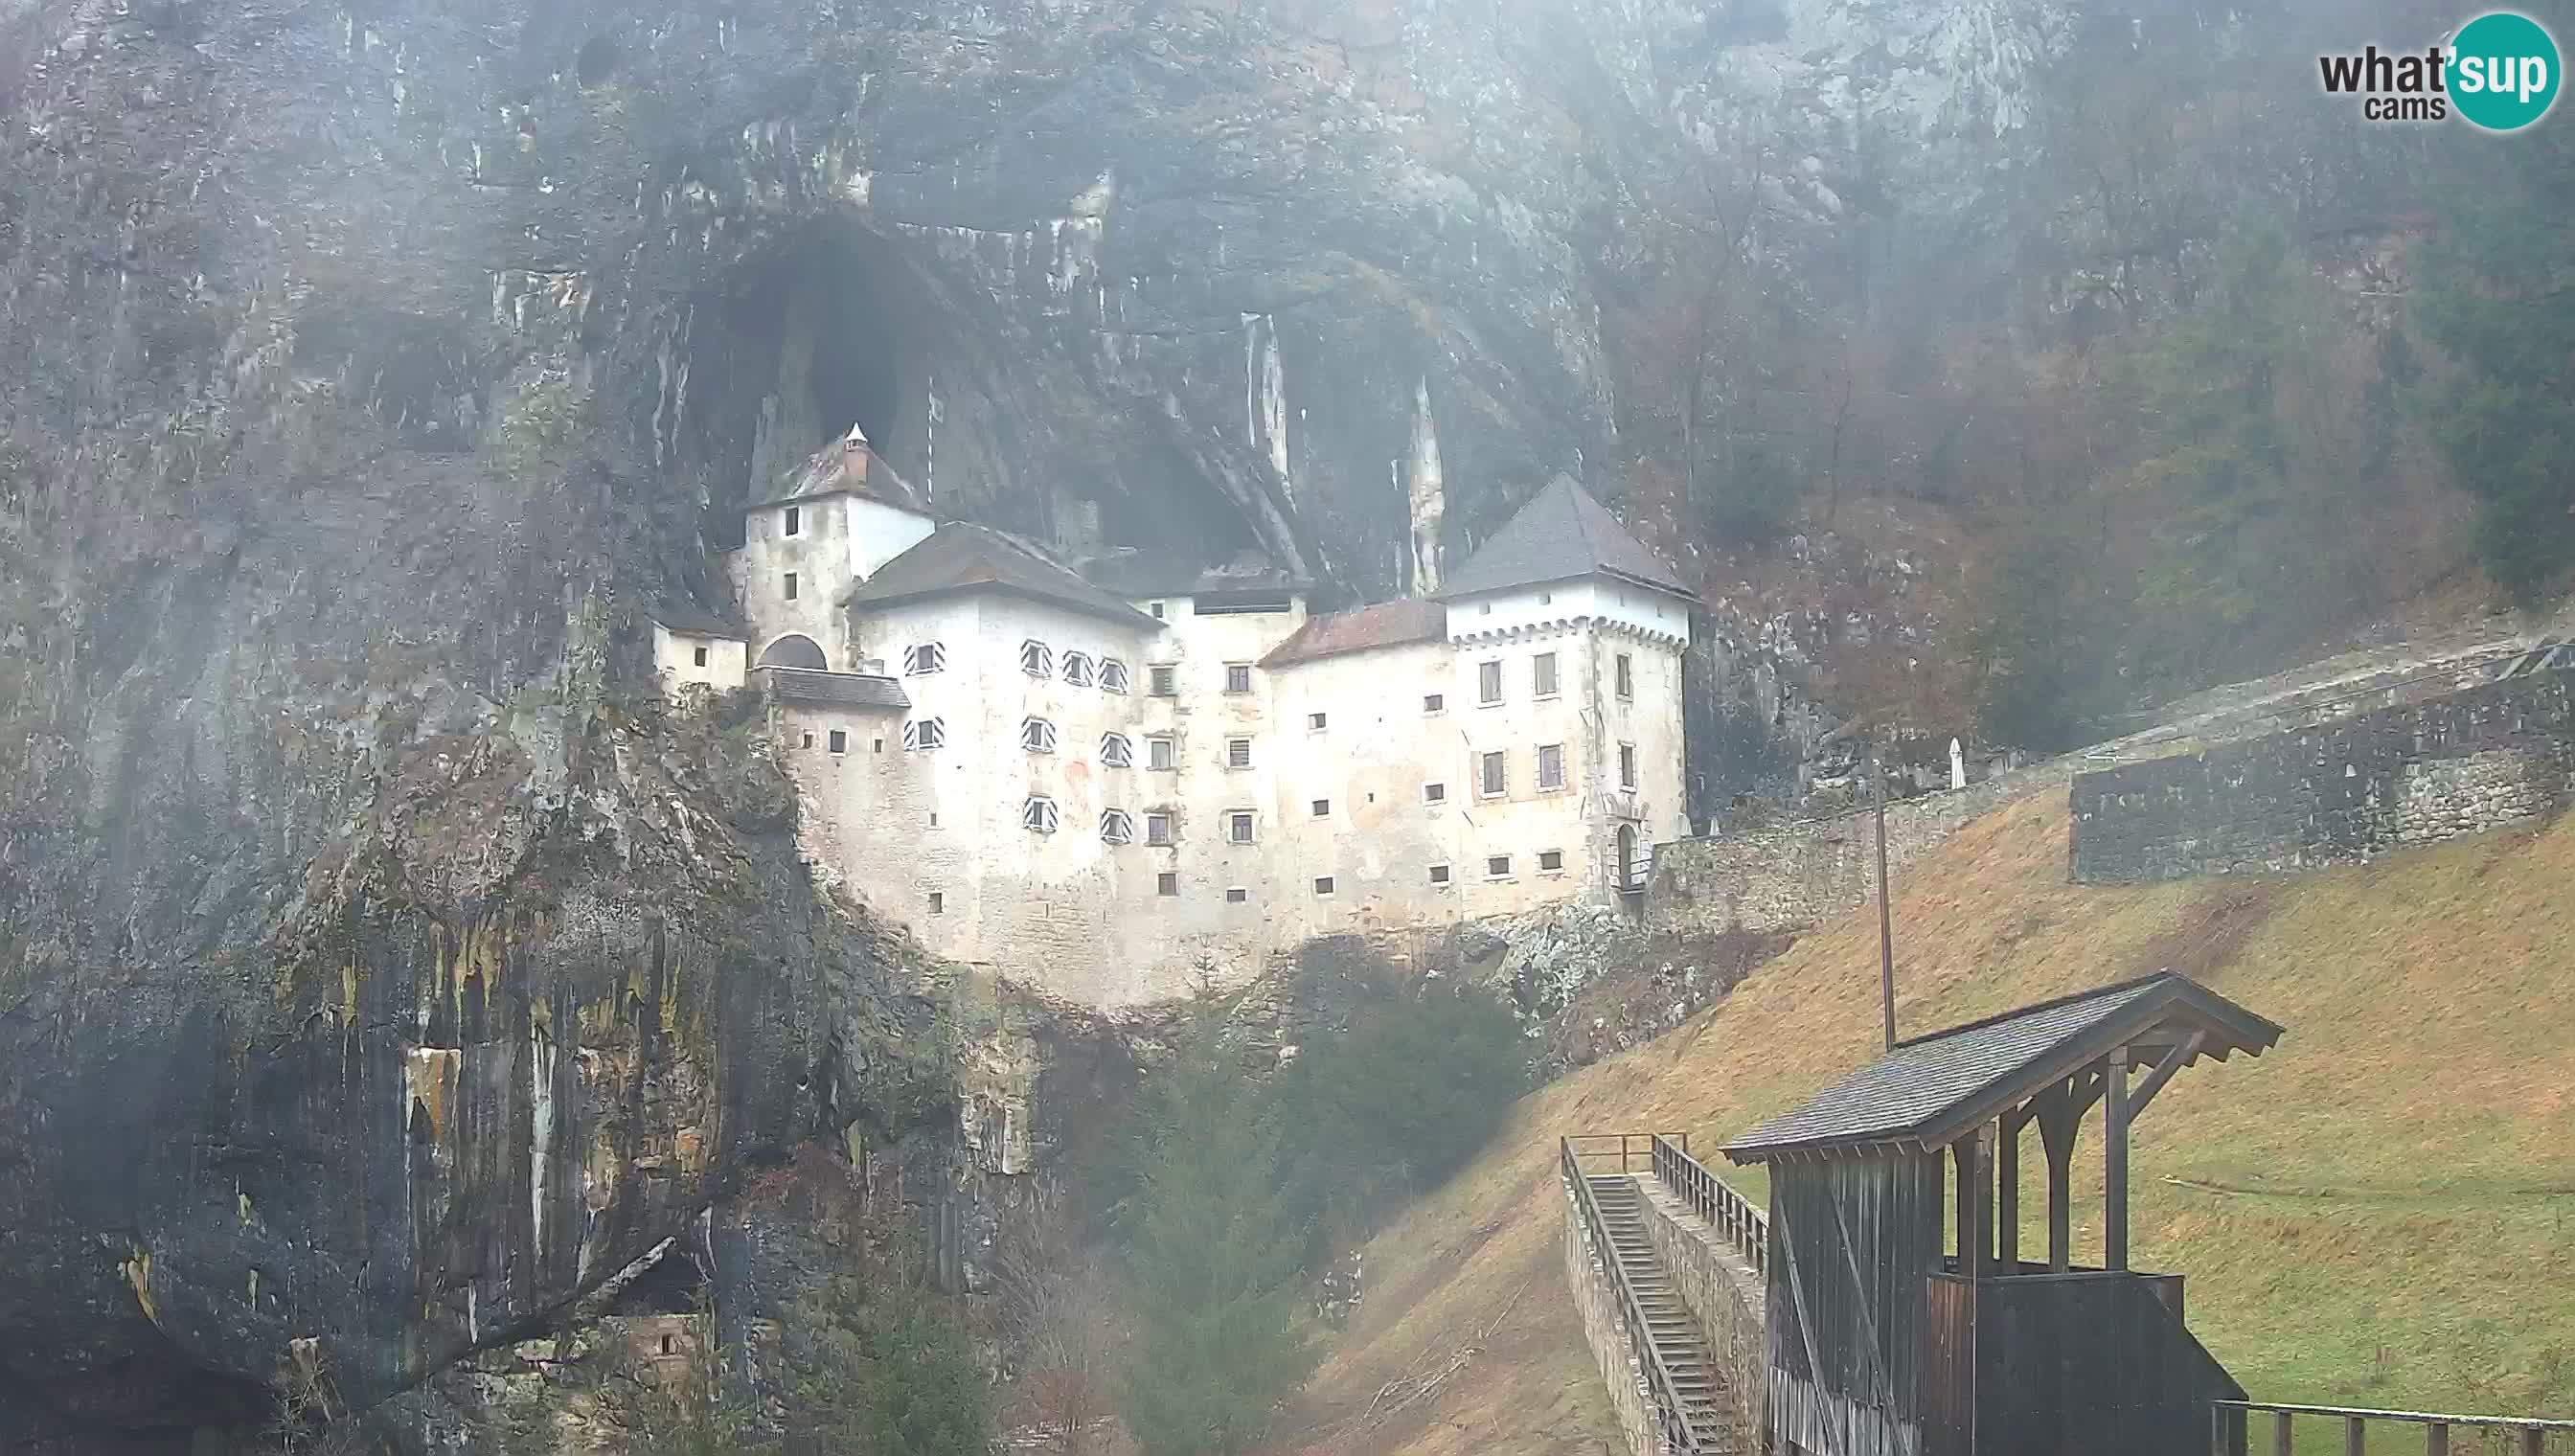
[2415,119,2575,603]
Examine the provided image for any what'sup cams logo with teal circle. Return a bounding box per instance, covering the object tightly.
[2315,11,2564,131]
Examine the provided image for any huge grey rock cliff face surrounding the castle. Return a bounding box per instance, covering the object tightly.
[0,0,2420,1451]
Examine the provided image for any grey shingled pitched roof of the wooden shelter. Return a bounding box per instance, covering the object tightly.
[1725,971,2282,1162]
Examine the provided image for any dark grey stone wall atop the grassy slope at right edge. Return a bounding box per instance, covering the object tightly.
[2070,672,2575,884]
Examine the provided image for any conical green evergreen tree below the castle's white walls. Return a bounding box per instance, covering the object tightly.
[1118,1015,1316,1456]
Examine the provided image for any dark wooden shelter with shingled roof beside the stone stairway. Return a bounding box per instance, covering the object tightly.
[1725,971,2282,1456]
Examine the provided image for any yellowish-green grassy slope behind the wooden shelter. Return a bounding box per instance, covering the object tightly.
[1306,794,2575,1456]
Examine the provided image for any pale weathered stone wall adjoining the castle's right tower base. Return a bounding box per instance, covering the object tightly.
[1646,761,2070,933]
